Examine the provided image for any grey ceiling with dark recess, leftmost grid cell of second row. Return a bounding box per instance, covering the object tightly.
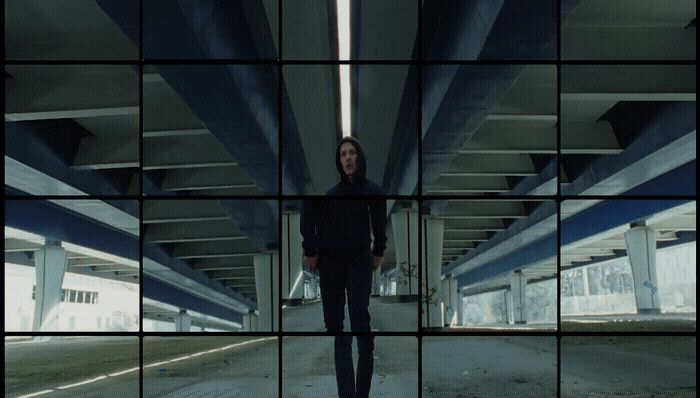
[5,65,139,195]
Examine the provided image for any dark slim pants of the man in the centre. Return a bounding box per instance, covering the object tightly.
[319,250,374,398]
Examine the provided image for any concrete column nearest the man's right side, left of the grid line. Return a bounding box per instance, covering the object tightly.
[391,209,419,295]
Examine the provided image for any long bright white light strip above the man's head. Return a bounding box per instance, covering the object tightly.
[336,0,352,137]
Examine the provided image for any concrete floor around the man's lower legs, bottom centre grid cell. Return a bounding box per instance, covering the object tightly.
[282,336,418,398]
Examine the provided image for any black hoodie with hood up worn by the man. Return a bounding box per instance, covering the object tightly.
[301,137,386,257]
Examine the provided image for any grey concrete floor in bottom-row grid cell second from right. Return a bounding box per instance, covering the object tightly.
[423,336,557,398]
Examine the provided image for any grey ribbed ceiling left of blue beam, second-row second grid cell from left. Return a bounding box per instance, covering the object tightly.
[143,66,262,195]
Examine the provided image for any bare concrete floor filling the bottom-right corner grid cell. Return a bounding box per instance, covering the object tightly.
[561,336,696,398]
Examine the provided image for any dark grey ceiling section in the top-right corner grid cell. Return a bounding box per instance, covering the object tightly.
[561,0,696,60]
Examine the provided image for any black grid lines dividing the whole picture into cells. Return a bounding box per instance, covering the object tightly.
[2,0,697,397]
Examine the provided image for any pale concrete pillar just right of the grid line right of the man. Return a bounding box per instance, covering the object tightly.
[422,216,445,327]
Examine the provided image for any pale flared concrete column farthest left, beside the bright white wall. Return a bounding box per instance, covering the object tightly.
[32,241,68,331]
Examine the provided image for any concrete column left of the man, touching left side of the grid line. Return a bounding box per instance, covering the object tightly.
[253,251,280,332]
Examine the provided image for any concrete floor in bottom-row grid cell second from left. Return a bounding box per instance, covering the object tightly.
[143,336,279,398]
